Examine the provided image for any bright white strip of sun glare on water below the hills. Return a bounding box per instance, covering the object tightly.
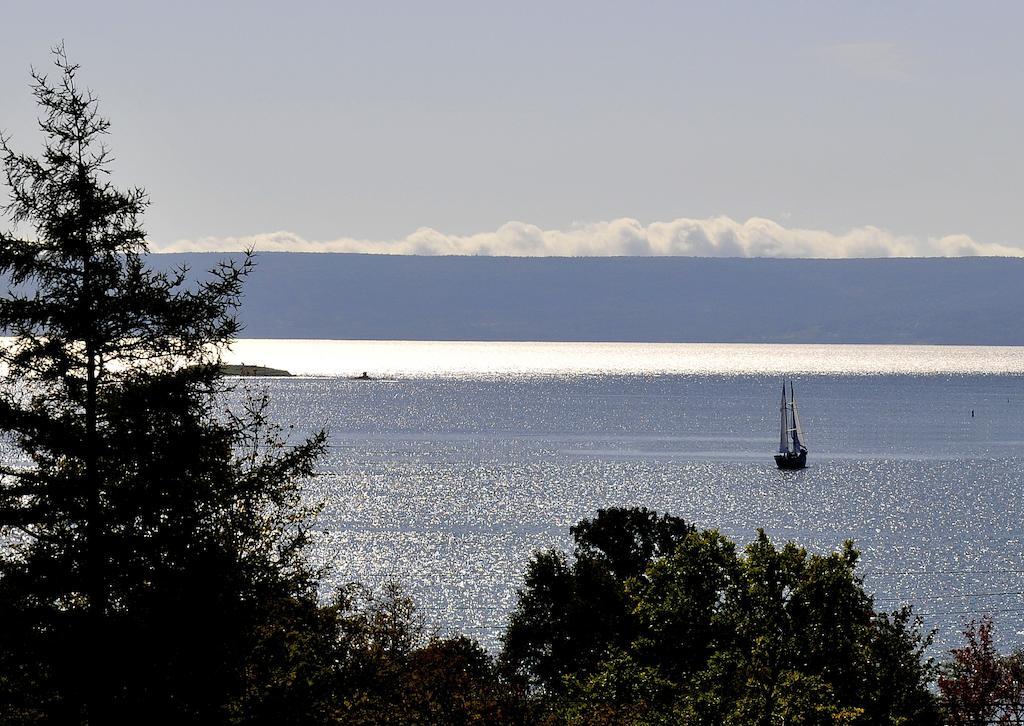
[227,339,1024,378]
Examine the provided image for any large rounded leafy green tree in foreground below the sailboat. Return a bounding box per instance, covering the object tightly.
[503,510,939,726]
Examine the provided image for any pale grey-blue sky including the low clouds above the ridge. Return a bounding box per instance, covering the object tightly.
[0,0,1024,257]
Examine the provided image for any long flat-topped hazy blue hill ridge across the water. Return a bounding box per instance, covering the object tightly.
[152,253,1024,345]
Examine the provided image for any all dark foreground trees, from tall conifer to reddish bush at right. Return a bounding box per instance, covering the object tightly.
[0,47,1024,726]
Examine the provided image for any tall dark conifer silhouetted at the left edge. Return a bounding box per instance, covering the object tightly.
[0,47,324,723]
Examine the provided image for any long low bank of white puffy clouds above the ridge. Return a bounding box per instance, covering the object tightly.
[154,217,1024,258]
